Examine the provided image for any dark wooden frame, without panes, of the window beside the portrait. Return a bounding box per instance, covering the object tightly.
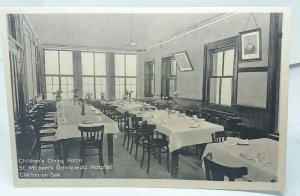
[202,36,239,111]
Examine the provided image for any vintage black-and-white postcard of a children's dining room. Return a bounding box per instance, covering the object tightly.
[1,8,290,190]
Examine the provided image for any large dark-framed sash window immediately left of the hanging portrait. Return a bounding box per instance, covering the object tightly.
[205,37,237,106]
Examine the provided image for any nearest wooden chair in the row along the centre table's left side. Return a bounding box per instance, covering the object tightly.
[141,122,169,175]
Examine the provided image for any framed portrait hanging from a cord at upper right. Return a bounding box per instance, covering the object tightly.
[239,28,261,61]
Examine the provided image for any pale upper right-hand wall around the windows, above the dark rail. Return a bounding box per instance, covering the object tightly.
[138,14,269,99]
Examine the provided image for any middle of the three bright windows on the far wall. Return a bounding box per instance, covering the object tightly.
[81,52,106,99]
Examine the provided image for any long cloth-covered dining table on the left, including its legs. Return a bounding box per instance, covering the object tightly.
[55,101,119,165]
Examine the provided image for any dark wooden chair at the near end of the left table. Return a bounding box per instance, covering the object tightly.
[78,124,106,177]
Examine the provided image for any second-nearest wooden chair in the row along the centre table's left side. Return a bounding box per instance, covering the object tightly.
[129,116,143,159]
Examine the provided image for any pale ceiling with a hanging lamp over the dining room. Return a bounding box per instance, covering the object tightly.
[26,14,225,50]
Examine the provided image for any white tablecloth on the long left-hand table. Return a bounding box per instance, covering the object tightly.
[55,101,119,140]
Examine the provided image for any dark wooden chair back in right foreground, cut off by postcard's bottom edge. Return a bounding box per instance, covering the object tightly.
[203,153,248,181]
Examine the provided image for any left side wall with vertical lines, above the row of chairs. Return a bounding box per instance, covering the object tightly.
[8,15,43,118]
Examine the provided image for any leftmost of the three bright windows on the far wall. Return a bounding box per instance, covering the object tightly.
[45,50,74,100]
